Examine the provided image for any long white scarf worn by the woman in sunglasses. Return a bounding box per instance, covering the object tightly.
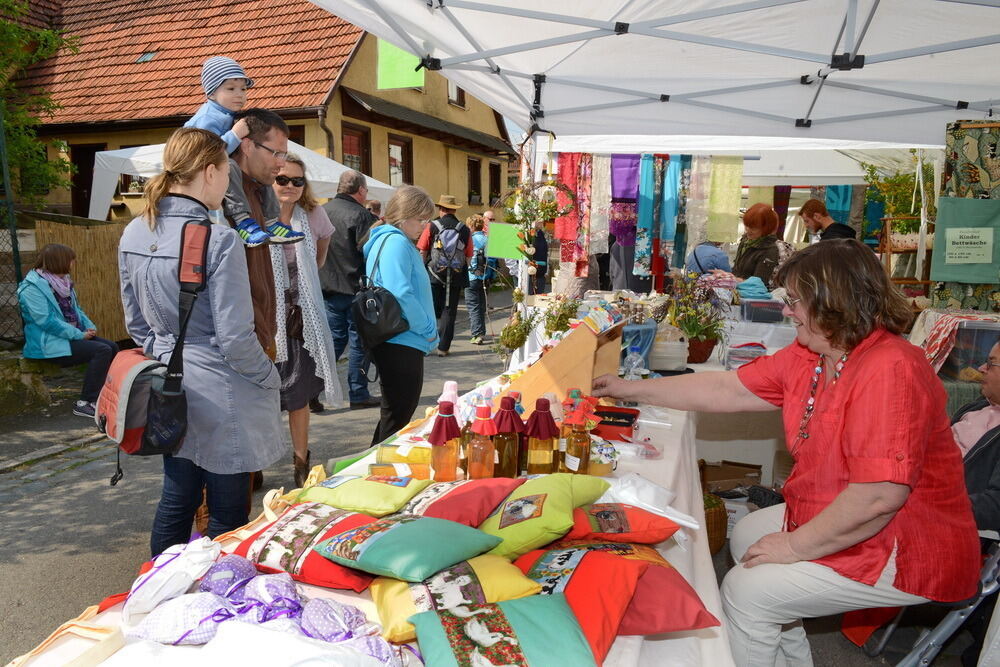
[270,205,344,406]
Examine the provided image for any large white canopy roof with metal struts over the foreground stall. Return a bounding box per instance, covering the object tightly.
[314,0,1000,145]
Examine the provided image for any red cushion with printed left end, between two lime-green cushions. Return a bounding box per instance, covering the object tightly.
[400,477,524,528]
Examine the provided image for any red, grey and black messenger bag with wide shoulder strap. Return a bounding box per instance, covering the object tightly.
[94,220,212,486]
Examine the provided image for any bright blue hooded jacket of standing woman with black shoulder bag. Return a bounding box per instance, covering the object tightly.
[364,225,438,354]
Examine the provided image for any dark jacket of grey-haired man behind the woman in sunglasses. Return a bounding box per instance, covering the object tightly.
[319,194,377,296]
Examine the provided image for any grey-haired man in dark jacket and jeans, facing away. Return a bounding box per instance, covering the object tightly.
[318,170,381,410]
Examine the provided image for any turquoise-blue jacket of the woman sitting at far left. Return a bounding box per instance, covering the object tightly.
[17,269,97,359]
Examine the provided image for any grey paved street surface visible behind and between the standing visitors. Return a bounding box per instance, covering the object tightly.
[0,294,510,664]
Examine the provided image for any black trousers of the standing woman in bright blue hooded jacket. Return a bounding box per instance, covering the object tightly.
[372,343,424,445]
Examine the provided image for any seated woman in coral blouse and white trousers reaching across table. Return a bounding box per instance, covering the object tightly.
[594,239,980,665]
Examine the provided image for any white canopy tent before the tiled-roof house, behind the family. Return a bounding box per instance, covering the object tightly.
[89,141,395,220]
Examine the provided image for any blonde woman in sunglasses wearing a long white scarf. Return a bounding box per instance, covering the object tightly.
[271,154,342,487]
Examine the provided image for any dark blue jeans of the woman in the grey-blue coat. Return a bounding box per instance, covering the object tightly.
[149,456,250,557]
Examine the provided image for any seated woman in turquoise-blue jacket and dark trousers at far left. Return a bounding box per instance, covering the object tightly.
[17,243,118,419]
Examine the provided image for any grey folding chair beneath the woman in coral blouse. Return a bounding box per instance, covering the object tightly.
[862,543,1000,667]
